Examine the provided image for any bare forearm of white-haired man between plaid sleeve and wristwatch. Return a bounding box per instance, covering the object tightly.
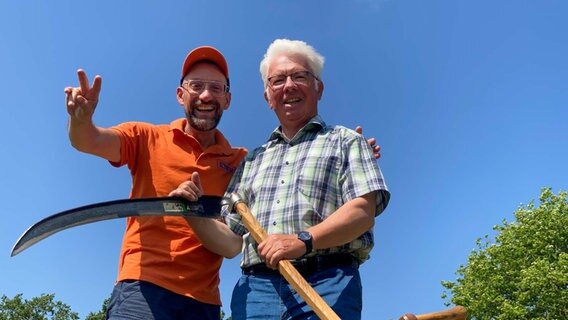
[308,192,376,249]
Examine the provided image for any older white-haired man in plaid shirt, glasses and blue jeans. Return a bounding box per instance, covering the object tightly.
[225,39,390,320]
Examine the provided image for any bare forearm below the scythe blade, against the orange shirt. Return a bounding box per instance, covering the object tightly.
[186,217,243,258]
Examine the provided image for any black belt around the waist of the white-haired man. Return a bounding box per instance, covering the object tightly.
[242,253,359,277]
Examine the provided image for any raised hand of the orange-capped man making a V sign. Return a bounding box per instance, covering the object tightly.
[64,69,103,123]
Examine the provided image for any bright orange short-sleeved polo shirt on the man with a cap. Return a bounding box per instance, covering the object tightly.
[111,119,246,305]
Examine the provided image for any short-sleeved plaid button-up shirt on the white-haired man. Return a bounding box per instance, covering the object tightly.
[223,116,390,267]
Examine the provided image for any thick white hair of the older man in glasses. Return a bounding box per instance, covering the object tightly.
[260,39,325,87]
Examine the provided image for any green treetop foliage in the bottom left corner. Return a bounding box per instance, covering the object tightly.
[0,294,79,320]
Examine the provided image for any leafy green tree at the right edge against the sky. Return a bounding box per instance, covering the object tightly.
[442,188,568,320]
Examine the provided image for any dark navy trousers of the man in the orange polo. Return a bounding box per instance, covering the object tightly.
[107,280,221,320]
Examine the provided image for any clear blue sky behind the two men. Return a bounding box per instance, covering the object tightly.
[0,0,568,320]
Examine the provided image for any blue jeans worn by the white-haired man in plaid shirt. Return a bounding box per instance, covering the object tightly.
[231,266,363,320]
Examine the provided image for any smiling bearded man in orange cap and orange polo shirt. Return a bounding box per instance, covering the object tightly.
[65,47,246,319]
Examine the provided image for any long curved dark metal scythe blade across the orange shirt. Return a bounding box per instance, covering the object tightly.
[11,196,221,257]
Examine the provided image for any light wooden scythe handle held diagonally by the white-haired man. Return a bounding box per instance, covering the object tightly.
[234,202,340,320]
